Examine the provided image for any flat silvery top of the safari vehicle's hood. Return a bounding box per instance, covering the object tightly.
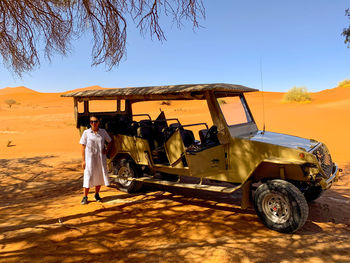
[243,131,318,151]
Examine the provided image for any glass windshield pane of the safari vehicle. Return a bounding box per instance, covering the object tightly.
[217,96,252,126]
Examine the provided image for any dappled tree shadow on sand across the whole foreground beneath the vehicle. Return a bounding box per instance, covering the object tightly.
[0,160,350,263]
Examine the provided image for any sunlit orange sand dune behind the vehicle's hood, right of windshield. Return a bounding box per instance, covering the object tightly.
[247,88,350,161]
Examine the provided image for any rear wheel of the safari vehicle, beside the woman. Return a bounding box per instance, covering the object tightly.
[113,159,142,193]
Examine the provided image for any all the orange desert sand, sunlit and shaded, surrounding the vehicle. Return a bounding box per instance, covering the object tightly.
[0,88,350,262]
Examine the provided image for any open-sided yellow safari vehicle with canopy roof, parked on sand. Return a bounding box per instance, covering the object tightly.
[63,84,339,233]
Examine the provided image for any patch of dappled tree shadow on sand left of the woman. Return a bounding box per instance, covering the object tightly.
[0,155,81,207]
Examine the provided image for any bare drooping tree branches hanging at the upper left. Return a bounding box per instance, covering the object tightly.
[0,0,205,75]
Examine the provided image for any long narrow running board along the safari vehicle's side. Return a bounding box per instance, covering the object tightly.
[109,175,242,194]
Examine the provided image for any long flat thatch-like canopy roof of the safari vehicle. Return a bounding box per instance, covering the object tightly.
[62,83,258,101]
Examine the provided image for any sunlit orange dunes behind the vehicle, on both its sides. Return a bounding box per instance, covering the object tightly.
[0,81,350,161]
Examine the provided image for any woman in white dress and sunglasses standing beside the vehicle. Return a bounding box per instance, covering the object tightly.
[80,116,112,205]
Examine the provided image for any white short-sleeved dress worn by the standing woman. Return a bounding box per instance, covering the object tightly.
[80,128,112,188]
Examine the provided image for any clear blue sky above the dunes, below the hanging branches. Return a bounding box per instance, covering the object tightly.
[0,0,350,92]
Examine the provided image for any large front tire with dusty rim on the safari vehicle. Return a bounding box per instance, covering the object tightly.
[254,179,309,233]
